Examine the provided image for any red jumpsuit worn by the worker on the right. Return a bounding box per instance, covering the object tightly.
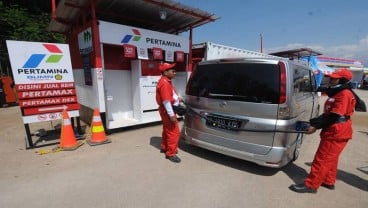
[304,89,356,190]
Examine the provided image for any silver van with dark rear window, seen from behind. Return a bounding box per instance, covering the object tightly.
[181,58,319,168]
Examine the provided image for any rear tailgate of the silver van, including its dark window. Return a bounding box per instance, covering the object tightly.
[185,61,280,154]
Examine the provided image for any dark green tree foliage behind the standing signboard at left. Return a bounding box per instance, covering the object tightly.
[0,1,65,76]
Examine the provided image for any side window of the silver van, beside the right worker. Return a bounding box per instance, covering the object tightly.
[294,67,312,95]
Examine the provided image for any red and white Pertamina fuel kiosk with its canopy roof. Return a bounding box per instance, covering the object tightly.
[48,0,217,130]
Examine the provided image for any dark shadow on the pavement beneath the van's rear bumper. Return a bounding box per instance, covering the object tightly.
[179,141,280,176]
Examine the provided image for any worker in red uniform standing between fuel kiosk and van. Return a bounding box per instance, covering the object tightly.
[156,63,181,163]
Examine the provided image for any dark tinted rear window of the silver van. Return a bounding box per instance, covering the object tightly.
[187,63,280,104]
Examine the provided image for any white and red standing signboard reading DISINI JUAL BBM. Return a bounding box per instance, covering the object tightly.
[6,40,80,123]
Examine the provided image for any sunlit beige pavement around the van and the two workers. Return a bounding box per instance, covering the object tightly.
[0,90,368,208]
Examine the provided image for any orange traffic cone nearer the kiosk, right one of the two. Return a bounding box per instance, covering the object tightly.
[87,108,111,146]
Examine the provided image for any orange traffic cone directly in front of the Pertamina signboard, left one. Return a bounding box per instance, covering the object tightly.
[59,110,83,150]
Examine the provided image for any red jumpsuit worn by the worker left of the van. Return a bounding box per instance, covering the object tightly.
[156,76,180,157]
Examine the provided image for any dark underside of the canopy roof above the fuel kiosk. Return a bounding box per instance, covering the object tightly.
[48,0,219,34]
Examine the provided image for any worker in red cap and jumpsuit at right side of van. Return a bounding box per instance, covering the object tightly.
[289,68,356,193]
